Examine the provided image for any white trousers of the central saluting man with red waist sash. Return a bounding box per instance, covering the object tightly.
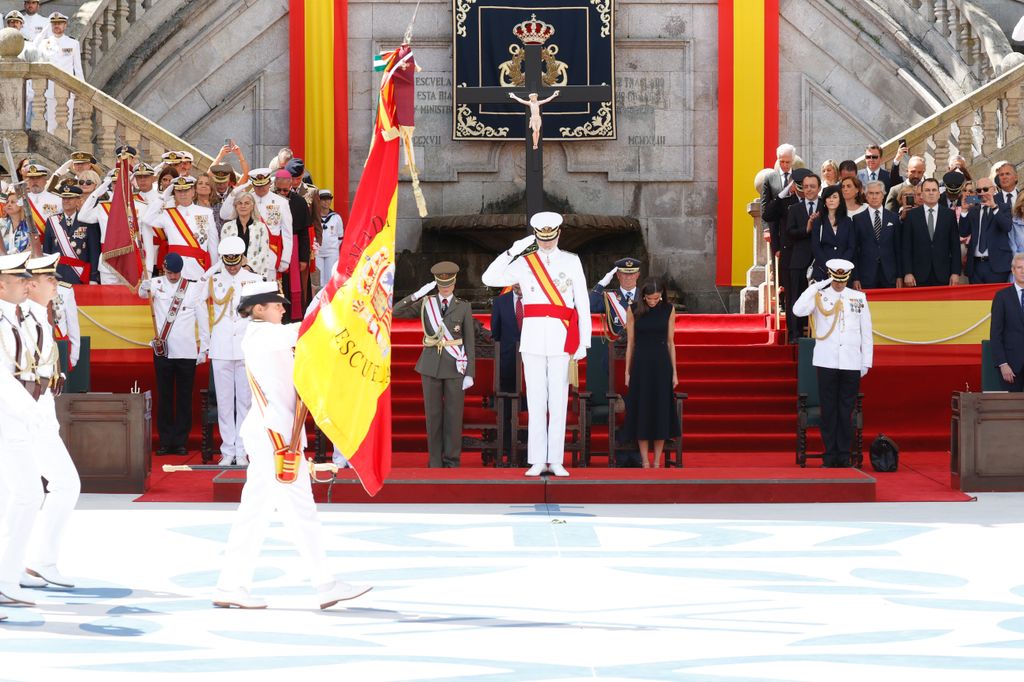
[522,353,569,464]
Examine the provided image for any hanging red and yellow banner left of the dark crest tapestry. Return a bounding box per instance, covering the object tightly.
[289,0,350,218]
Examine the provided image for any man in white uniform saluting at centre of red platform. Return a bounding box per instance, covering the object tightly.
[482,211,591,476]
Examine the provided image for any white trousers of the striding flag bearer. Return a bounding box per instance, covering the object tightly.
[217,419,335,592]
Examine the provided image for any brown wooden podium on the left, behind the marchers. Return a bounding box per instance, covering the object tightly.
[56,391,153,494]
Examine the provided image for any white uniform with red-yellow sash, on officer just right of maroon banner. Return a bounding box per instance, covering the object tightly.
[140,178,219,282]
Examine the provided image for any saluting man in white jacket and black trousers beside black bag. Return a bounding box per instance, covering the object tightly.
[793,258,874,467]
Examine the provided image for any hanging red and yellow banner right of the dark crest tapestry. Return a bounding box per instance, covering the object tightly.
[715,0,778,287]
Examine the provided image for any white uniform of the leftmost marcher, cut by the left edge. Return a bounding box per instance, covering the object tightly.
[0,300,43,590]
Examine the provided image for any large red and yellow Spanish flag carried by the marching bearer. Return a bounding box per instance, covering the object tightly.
[295,52,401,496]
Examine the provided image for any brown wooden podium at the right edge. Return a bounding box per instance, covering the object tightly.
[949,392,1024,493]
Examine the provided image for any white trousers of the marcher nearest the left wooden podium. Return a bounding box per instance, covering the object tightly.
[26,392,82,568]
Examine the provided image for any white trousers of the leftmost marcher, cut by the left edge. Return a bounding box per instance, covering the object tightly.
[0,413,43,585]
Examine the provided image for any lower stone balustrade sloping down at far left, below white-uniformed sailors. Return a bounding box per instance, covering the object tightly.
[0,60,213,170]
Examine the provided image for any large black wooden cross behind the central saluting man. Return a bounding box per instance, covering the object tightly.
[455,44,611,220]
